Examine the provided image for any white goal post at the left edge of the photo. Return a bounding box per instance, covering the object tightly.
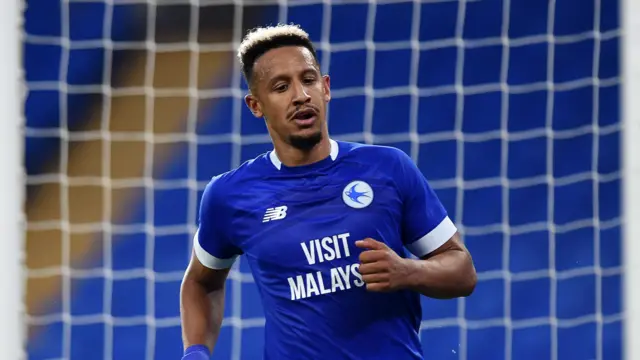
[0,0,25,359]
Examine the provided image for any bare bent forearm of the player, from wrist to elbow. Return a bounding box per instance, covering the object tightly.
[406,250,477,299]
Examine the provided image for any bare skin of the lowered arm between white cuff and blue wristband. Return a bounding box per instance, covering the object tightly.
[180,280,224,351]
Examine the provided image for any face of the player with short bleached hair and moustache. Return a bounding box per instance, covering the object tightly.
[245,46,331,150]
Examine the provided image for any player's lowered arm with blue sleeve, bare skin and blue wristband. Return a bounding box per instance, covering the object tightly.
[180,180,241,360]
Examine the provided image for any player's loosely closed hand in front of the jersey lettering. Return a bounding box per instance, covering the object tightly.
[356,238,408,292]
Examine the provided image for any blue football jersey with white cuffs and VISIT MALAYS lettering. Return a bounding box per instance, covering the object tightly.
[194,140,456,360]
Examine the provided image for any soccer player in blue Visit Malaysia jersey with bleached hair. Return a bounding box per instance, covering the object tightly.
[181,25,476,360]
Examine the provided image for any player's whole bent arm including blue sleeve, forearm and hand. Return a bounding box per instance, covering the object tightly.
[356,151,477,299]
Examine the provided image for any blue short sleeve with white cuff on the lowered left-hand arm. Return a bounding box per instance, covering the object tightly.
[193,179,242,269]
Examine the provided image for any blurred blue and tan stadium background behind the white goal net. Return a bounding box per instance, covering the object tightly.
[13,0,623,360]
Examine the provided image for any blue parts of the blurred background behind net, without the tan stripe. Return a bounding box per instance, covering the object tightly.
[24,0,622,360]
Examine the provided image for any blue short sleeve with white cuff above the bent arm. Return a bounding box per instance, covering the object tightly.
[398,150,458,258]
